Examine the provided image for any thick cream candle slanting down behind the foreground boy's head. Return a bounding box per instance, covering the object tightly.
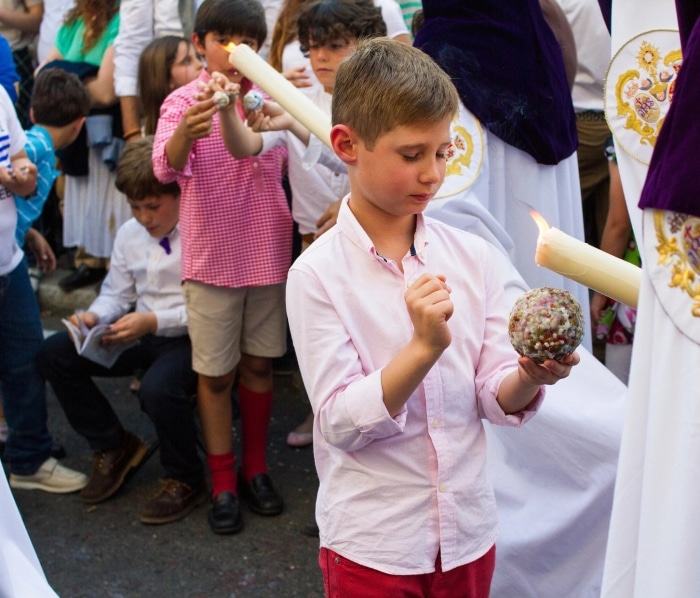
[226,44,331,147]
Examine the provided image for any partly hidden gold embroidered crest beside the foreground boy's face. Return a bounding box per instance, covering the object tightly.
[436,104,485,198]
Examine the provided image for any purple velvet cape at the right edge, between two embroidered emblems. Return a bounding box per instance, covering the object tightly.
[639,0,700,216]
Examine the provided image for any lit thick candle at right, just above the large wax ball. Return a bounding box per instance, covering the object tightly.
[532,213,641,308]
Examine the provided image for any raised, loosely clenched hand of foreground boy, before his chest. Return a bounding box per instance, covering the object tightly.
[404,274,454,353]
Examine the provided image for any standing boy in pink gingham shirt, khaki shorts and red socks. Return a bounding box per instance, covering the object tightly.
[153,0,292,534]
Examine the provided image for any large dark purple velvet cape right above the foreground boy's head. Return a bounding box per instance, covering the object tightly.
[414,0,578,164]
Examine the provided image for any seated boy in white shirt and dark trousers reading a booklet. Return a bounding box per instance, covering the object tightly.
[38,138,206,524]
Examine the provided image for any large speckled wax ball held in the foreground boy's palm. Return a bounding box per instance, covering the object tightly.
[508,287,585,363]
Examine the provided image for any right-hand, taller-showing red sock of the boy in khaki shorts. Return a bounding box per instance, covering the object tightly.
[238,384,272,480]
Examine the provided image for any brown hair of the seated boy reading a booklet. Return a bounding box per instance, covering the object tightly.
[114,135,180,201]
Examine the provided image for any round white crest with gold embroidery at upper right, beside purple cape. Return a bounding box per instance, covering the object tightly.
[605,30,682,164]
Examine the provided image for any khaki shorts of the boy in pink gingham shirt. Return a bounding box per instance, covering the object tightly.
[183,280,287,377]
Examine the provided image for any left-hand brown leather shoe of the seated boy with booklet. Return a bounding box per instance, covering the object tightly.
[80,432,148,504]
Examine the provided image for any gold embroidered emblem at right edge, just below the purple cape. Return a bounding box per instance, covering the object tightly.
[654,210,700,318]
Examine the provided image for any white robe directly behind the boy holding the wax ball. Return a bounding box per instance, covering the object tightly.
[427,105,626,598]
